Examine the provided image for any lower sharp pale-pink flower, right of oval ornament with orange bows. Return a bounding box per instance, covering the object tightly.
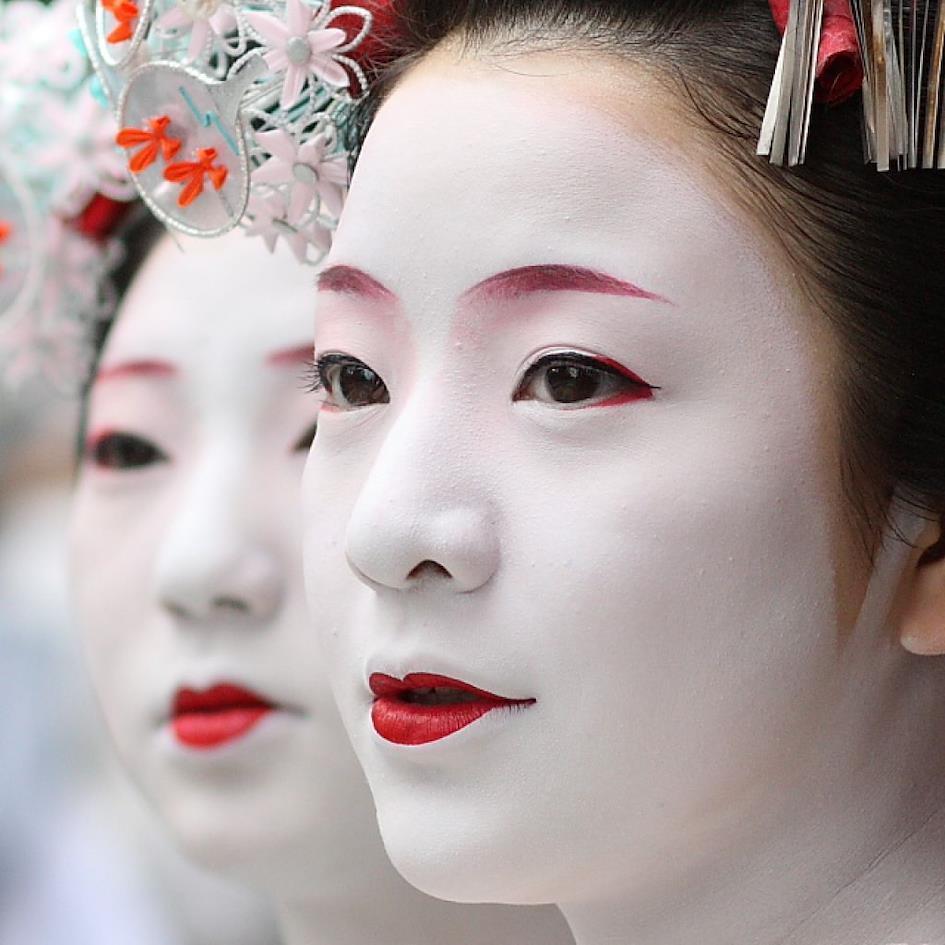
[253,129,348,225]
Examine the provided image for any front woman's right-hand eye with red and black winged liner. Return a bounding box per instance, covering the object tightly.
[512,351,659,409]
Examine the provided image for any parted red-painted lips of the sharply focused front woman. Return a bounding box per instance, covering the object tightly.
[369,673,535,745]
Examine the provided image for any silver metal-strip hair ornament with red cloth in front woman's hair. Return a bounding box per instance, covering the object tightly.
[758,0,945,171]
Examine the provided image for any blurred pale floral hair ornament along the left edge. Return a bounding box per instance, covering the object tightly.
[0,0,135,393]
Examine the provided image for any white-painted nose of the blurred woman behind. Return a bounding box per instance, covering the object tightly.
[155,456,285,623]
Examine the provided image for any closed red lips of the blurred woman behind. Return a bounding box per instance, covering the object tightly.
[171,683,276,751]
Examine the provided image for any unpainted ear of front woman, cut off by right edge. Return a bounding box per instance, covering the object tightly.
[898,519,945,656]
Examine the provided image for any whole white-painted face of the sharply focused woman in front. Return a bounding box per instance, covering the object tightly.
[305,54,876,903]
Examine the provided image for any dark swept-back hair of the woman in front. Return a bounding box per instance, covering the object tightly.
[349,0,945,558]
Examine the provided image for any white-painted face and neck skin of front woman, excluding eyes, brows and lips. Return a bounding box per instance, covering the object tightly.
[304,49,945,945]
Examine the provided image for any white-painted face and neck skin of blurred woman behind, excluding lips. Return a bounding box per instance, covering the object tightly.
[72,233,570,945]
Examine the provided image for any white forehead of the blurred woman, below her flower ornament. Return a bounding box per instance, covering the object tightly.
[102,231,315,373]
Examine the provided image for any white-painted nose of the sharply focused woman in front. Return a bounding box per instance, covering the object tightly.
[345,404,500,593]
